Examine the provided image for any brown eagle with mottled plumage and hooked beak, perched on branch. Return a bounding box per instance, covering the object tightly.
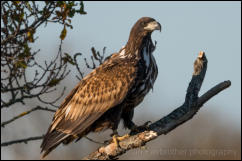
[41,17,161,158]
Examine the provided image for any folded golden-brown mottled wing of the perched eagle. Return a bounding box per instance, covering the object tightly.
[50,56,136,136]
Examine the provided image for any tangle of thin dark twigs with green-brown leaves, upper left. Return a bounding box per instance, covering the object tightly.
[1,1,86,108]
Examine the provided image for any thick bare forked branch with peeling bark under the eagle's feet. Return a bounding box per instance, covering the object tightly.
[83,52,231,160]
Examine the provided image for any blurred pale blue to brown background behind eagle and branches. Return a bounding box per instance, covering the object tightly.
[1,2,241,159]
